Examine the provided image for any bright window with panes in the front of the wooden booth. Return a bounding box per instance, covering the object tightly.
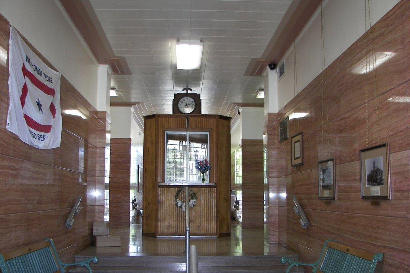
[165,131,209,183]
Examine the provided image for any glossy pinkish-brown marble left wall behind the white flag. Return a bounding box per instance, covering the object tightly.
[0,16,106,257]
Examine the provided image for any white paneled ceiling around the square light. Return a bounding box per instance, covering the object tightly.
[91,0,292,115]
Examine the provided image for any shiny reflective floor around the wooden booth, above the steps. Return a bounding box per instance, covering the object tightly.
[79,221,292,256]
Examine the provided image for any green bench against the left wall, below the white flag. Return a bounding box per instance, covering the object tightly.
[0,239,98,273]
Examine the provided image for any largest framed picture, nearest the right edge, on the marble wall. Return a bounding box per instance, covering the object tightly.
[360,144,391,199]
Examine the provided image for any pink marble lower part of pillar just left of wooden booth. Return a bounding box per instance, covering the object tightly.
[110,138,131,227]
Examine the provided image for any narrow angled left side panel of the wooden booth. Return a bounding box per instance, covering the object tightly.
[142,116,158,235]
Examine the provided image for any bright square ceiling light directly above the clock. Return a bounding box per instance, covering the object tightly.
[176,40,202,70]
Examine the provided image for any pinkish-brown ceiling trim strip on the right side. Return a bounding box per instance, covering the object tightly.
[245,0,322,76]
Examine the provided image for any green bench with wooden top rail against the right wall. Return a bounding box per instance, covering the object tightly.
[281,240,383,273]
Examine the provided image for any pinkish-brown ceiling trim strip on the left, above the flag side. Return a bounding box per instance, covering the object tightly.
[60,0,131,75]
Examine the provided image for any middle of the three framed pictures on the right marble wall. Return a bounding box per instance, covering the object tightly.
[318,159,336,200]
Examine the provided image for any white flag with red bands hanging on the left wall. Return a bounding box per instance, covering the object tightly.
[7,27,62,149]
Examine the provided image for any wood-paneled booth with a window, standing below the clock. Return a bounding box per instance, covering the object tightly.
[143,115,231,236]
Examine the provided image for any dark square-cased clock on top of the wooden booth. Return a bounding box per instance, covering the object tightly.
[172,92,201,115]
